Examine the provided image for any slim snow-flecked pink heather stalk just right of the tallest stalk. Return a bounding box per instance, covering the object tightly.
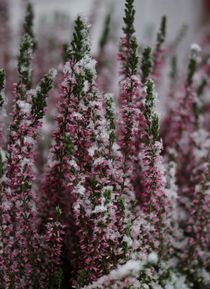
[142,80,168,256]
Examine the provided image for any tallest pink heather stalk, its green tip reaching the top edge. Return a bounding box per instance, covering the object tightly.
[118,1,142,189]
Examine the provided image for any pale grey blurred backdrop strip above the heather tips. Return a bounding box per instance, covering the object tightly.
[8,0,210,53]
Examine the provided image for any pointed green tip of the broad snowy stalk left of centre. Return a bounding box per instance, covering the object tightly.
[65,16,90,62]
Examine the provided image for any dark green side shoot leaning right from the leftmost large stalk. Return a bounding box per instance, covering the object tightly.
[32,70,54,120]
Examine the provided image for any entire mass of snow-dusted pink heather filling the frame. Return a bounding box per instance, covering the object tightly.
[0,0,210,289]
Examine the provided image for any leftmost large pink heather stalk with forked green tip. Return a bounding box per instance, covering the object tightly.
[1,19,54,288]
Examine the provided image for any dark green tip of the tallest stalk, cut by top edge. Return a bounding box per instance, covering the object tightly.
[123,0,135,37]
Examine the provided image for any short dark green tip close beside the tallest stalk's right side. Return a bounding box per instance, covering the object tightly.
[141,46,152,84]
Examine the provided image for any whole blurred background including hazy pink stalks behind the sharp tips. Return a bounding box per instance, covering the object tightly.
[0,0,210,112]
